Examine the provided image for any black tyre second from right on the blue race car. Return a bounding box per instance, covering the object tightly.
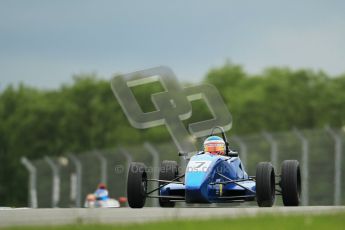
[256,162,275,207]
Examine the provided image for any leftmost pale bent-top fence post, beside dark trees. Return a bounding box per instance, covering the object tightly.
[20,157,38,208]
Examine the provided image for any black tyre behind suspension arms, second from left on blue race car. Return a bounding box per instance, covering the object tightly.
[159,161,178,208]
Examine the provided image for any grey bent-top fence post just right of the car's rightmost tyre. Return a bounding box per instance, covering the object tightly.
[293,128,309,206]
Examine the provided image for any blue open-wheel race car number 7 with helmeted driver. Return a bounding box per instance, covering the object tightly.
[127,127,301,208]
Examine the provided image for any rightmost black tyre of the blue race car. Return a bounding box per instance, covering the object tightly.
[280,160,301,206]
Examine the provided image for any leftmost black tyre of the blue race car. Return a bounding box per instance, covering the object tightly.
[127,162,147,208]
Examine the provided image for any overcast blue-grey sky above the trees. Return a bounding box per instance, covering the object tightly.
[0,0,345,90]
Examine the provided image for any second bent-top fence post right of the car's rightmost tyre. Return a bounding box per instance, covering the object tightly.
[325,126,343,205]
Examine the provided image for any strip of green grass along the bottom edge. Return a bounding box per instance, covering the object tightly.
[5,212,345,230]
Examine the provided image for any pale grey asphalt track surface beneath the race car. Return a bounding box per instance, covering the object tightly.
[0,206,345,227]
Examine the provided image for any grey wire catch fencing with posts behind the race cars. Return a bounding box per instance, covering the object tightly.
[22,127,345,208]
